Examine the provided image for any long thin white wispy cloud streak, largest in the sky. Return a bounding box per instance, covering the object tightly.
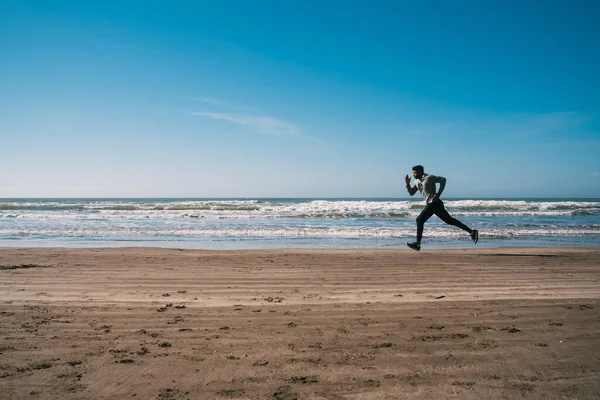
[191,112,323,143]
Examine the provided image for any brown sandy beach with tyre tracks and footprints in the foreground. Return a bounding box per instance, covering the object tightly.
[0,248,600,399]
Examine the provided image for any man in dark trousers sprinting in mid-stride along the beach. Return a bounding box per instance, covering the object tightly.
[404,165,479,251]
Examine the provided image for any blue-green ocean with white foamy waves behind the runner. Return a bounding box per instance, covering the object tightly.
[0,198,600,250]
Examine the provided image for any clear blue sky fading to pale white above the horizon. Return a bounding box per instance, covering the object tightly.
[0,0,600,198]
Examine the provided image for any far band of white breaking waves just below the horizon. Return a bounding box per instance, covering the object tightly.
[0,200,600,220]
